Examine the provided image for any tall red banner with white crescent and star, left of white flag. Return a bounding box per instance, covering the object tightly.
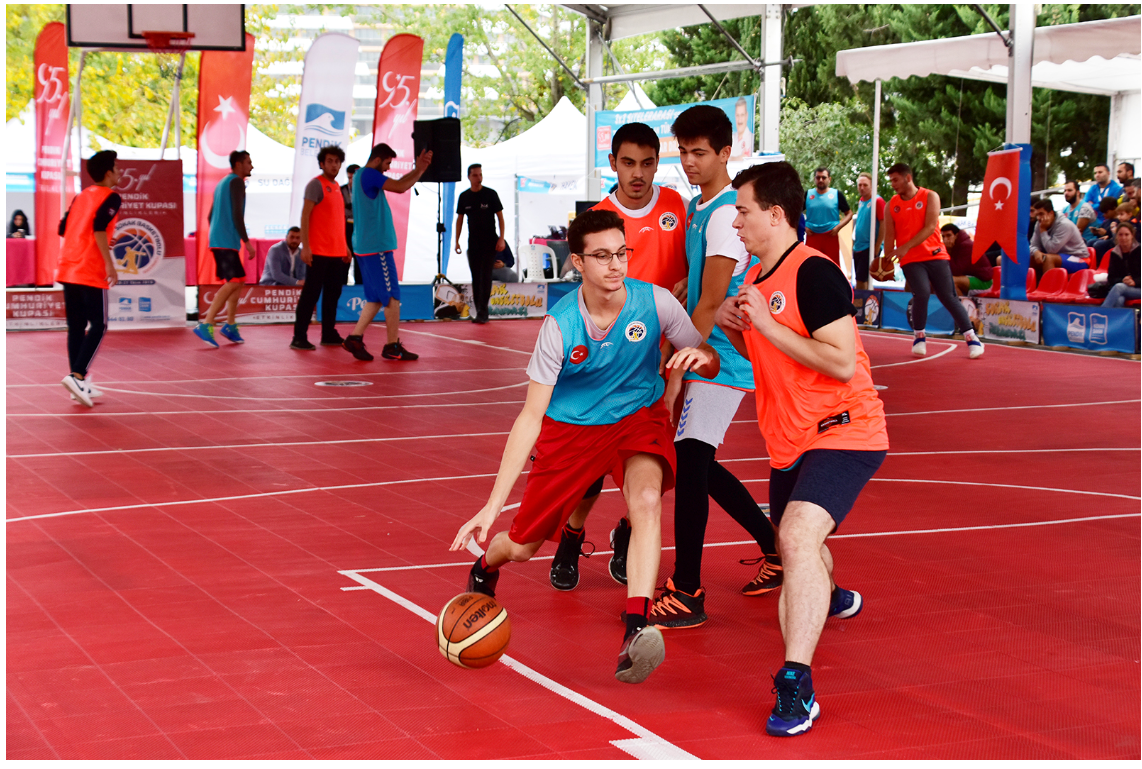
[196,34,257,285]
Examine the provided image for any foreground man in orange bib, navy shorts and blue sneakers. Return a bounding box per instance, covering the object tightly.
[715,162,888,737]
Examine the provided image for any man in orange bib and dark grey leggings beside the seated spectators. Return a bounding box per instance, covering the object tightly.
[884,163,983,359]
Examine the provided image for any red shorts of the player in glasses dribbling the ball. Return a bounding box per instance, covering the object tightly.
[508,400,677,545]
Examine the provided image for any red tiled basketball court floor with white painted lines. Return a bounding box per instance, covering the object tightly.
[6,321,1142,760]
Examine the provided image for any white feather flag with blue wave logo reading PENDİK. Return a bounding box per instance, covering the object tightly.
[287,32,360,225]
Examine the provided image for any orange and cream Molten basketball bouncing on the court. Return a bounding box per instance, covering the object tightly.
[436,593,512,670]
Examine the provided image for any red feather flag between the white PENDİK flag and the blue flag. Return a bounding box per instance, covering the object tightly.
[372,34,425,279]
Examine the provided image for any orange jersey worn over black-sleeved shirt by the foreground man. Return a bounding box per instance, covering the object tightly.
[743,243,888,470]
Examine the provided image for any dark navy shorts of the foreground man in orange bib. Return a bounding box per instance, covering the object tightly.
[770,449,888,529]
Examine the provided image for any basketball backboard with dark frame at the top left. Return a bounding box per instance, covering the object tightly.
[67,3,246,50]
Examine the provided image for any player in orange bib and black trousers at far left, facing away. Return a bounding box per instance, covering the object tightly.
[56,151,122,408]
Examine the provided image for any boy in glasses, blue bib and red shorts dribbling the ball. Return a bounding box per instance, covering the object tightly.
[451,210,718,683]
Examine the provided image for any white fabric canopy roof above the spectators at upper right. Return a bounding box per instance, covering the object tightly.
[837,16,1142,96]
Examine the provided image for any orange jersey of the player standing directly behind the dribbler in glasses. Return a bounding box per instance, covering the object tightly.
[593,186,686,291]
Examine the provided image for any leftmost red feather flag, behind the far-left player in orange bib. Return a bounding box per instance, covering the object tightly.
[32,22,74,286]
